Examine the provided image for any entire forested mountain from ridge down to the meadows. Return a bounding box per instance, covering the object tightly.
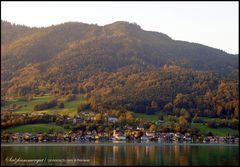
[1,21,239,118]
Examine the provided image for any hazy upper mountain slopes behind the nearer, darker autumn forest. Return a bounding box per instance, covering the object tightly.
[1,21,238,77]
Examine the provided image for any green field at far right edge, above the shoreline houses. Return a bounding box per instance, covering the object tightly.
[193,123,239,136]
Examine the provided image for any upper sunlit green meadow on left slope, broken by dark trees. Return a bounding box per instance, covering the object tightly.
[2,94,86,116]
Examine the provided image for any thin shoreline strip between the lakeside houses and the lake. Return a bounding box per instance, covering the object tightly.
[1,142,239,147]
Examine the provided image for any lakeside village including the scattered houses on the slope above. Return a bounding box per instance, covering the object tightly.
[1,112,239,144]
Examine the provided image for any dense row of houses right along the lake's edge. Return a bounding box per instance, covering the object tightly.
[1,130,239,144]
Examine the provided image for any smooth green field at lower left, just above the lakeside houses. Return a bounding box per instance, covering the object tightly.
[5,124,66,133]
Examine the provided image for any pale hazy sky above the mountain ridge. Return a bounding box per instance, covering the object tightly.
[1,1,239,54]
